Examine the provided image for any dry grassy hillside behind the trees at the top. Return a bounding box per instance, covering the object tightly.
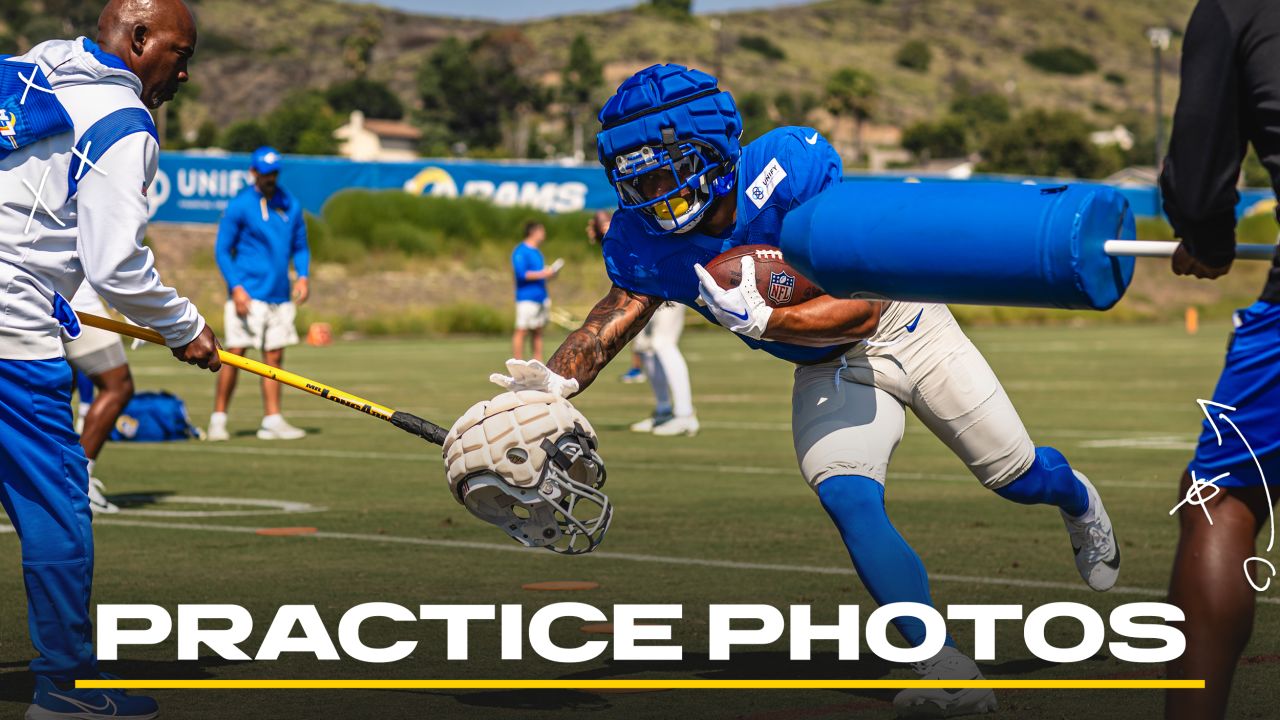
[0,0,1194,148]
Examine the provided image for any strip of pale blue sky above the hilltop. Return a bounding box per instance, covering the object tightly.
[353,0,806,20]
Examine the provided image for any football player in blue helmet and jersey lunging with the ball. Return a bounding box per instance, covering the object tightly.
[483,65,1120,716]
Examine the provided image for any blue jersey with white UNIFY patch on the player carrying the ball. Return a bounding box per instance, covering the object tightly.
[603,127,849,363]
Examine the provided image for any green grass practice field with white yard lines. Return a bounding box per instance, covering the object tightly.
[0,319,1280,720]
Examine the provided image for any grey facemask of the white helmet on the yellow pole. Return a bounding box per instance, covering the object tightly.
[458,424,613,555]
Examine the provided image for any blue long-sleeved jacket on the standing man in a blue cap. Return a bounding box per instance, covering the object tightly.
[214,184,311,302]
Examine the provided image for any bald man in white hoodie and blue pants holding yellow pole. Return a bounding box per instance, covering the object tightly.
[0,0,219,720]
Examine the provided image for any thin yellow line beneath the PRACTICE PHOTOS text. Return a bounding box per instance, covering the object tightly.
[76,680,1204,691]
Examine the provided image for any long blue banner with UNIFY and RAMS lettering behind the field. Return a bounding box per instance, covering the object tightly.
[148,152,1275,223]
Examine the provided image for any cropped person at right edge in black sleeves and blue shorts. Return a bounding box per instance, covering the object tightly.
[1160,0,1280,720]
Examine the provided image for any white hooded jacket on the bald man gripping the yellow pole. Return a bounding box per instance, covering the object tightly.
[0,37,205,360]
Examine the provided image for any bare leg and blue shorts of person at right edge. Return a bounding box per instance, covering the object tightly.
[1166,302,1280,717]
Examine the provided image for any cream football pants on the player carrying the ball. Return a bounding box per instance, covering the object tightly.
[791,302,1036,489]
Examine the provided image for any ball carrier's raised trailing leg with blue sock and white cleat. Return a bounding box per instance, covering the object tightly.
[896,304,1120,591]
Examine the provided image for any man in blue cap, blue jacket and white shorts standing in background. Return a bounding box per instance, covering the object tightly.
[207,147,311,441]
